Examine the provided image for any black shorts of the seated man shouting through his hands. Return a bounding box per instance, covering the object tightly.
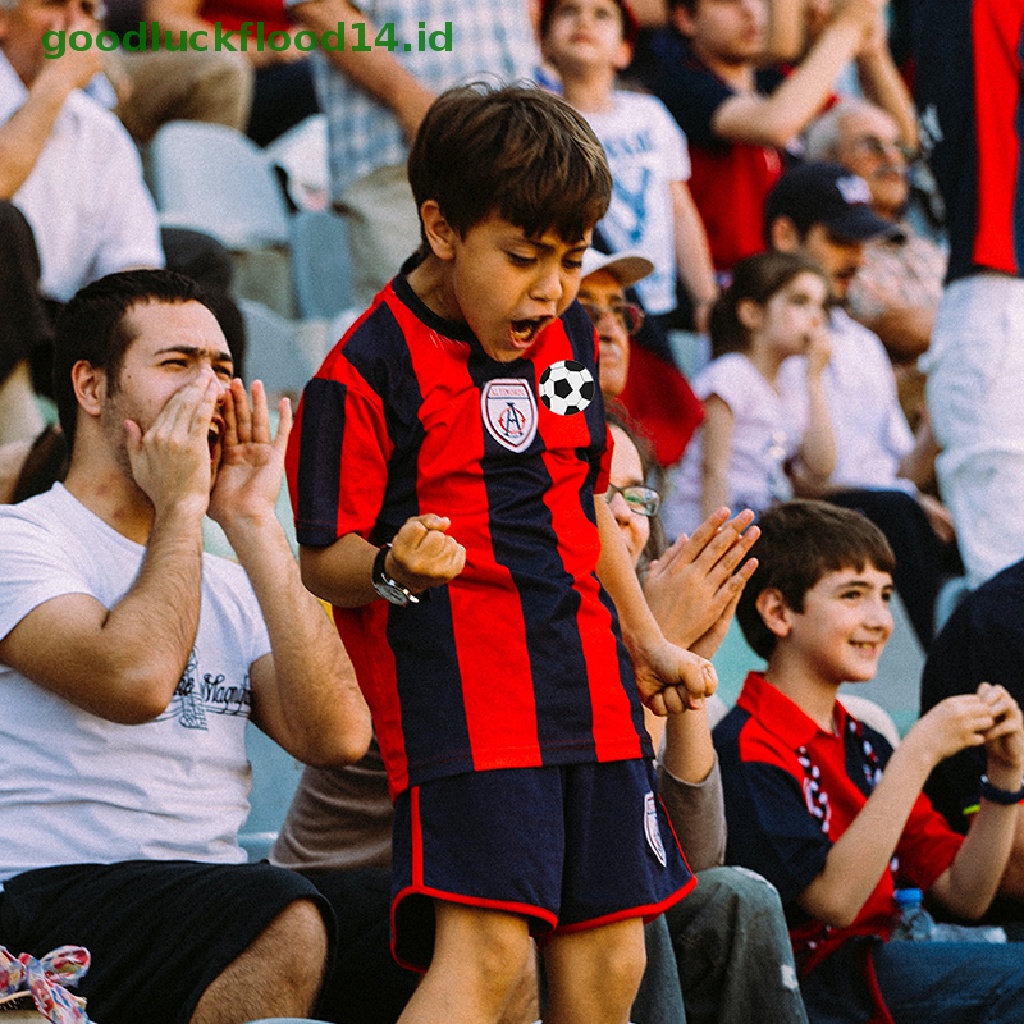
[0,860,335,1024]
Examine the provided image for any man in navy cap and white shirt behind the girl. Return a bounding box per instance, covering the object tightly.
[765,163,956,650]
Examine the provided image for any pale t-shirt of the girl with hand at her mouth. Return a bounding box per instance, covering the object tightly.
[662,352,809,538]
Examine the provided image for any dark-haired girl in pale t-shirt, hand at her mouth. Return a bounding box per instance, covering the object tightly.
[665,253,836,537]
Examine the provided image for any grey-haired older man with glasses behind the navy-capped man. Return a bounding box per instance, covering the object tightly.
[807,98,946,426]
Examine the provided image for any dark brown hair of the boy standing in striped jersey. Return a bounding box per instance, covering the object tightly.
[408,82,611,255]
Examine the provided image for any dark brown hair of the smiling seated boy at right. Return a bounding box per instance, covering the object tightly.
[736,501,896,658]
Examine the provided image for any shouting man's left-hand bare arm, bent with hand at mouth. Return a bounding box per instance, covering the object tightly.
[0,372,220,724]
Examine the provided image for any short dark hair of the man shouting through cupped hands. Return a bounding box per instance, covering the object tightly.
[53,270,213,449]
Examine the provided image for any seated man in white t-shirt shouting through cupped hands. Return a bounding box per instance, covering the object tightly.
[0,270,370,1024]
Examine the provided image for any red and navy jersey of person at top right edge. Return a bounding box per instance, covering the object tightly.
[913,0,1024,282]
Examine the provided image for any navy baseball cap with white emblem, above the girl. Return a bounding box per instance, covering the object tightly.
[765,162,894,242]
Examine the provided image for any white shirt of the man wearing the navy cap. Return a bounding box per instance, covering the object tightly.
[778,309,915,494]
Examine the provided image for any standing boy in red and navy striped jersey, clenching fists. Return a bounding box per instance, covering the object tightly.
[280,85,715,1024]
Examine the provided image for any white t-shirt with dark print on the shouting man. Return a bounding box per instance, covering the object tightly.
[0,484,270,882]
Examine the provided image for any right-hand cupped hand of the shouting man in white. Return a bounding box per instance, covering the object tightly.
[210,378,292,532]
